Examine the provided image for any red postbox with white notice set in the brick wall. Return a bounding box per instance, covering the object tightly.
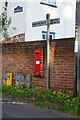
[35,49,41,74]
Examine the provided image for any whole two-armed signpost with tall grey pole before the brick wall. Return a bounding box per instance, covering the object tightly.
[32,14,60,90]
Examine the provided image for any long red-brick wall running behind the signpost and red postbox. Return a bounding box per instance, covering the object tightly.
[2,38,74,92]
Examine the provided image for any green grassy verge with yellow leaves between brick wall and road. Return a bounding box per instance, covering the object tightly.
[2,85,80,114]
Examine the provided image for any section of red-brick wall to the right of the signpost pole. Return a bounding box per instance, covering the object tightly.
[50,39,74,91]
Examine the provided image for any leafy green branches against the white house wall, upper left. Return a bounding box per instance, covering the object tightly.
[0,1,16,39]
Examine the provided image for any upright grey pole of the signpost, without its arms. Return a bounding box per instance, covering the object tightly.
[46,14,50,90]
